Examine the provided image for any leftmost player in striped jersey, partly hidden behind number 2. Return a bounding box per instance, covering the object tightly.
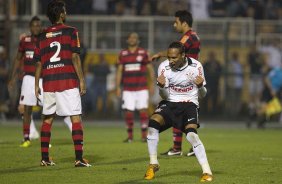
[9,16,71,148]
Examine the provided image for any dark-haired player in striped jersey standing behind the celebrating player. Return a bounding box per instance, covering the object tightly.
[151,10,200,156]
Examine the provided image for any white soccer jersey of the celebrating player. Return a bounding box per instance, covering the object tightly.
[158,58,206,106]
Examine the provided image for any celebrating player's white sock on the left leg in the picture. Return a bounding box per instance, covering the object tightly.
[147,127,159,164]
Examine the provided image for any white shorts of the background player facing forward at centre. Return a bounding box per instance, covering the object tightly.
[122,90,149,111]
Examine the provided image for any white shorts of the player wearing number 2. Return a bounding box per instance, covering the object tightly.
[42,88,82,116]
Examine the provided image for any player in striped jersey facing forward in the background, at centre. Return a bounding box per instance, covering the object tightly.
[116,32,155,142]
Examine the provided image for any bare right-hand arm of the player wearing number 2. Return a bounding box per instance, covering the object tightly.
[72,53,86,95]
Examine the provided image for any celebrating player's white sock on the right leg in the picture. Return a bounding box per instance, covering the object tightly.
[186,132,212,174]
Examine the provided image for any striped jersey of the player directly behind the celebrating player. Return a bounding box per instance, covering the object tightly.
[180,30,201,59]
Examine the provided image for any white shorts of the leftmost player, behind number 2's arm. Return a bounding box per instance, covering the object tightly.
[19,75,43,106]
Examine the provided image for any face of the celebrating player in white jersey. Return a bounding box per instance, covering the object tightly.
[167,48,185,69]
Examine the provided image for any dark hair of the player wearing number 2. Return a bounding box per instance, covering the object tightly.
[47,0,65,24]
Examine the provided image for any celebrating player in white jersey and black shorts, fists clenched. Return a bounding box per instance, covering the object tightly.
[144,42,213,182]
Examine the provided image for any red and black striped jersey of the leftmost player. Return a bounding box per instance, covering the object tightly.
[18,35,38,76]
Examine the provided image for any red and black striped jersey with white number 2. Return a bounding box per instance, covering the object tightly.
[37,24,80,92]
